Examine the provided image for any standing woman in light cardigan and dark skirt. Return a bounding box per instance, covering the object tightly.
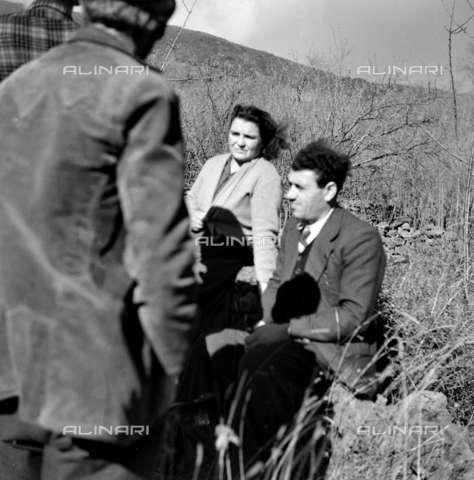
[186,105,288,334]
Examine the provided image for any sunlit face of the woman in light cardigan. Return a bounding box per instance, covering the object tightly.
[229,117,262,162]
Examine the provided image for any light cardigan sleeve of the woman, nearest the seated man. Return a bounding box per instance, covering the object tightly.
[251,170,283,284]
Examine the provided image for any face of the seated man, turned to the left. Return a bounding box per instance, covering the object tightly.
[285,170,337,223]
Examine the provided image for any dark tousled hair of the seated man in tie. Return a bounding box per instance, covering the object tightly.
[291,139,351,192]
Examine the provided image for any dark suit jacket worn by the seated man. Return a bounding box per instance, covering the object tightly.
[262,207,385,393]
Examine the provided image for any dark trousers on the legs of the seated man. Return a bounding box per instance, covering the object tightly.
[175,329,330,478]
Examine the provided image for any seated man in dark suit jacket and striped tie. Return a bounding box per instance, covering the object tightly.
[176,141,385,476]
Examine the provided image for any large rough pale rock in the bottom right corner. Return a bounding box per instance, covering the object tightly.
[326,385,474,480]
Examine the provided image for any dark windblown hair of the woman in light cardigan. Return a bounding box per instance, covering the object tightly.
[229,105,289,160]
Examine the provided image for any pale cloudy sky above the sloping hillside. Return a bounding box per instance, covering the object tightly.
[171,0,474,89]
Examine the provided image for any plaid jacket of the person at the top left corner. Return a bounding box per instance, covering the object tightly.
[0,0,79,81]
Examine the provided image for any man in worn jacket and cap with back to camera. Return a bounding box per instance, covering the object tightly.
[0,0,197,480]
